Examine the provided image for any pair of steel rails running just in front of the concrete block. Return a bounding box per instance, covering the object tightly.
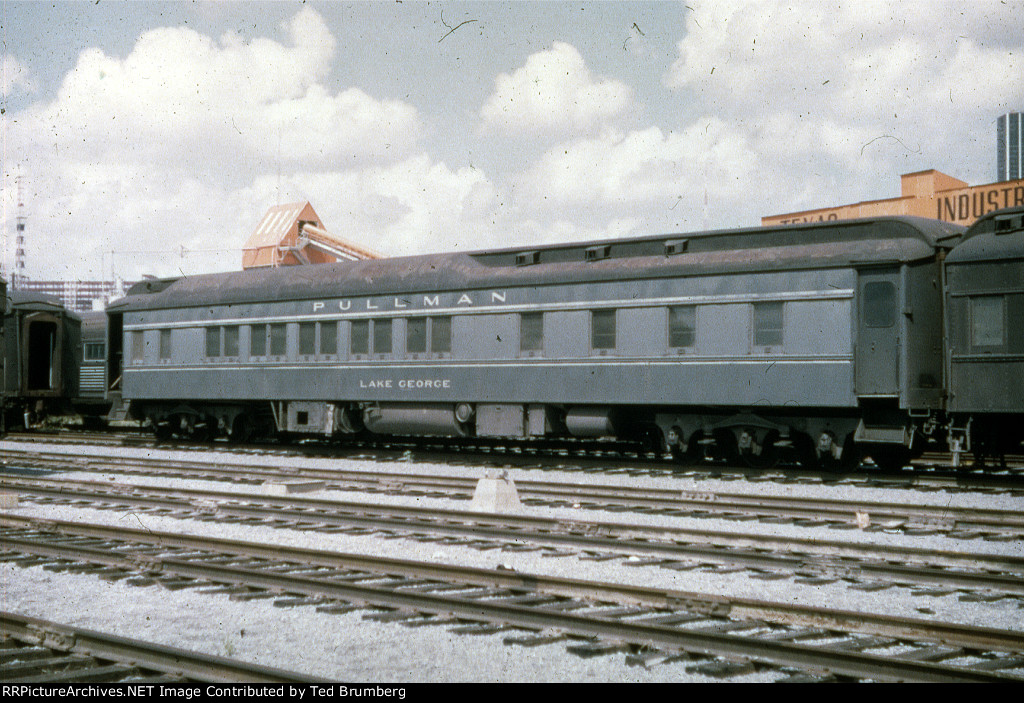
[6,479,1024,596]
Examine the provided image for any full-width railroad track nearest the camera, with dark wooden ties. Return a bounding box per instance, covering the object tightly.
[0,516,1024,683]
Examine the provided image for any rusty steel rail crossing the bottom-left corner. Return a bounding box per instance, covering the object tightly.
[0,612,325,684]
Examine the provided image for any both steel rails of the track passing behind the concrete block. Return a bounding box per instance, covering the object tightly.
[0,451,1024,531]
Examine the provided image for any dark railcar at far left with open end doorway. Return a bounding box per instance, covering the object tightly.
[3,291,81,428]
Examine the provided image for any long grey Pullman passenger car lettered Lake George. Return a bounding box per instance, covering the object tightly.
[108,218,964,465]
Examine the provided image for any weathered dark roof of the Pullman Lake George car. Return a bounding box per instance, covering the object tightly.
[108,217,964,311]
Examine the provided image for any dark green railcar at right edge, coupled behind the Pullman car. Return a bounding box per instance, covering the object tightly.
[945,208,1024,458]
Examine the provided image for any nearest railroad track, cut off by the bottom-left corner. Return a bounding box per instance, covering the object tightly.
[0,612,322,686]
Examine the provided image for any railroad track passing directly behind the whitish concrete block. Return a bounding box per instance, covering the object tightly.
[0,449,1024,540]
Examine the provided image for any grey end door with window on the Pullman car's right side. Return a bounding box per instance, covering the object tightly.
[854,268,900,396]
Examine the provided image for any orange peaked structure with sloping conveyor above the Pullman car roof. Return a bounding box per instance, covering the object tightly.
[242,203,381,268]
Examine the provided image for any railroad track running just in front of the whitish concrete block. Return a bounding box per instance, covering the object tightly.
[6,478,1024,598]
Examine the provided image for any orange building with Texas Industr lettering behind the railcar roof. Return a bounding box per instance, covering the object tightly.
[761,170,1024,226]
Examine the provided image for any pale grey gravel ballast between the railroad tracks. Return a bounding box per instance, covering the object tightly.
[0,442,1024,683]
